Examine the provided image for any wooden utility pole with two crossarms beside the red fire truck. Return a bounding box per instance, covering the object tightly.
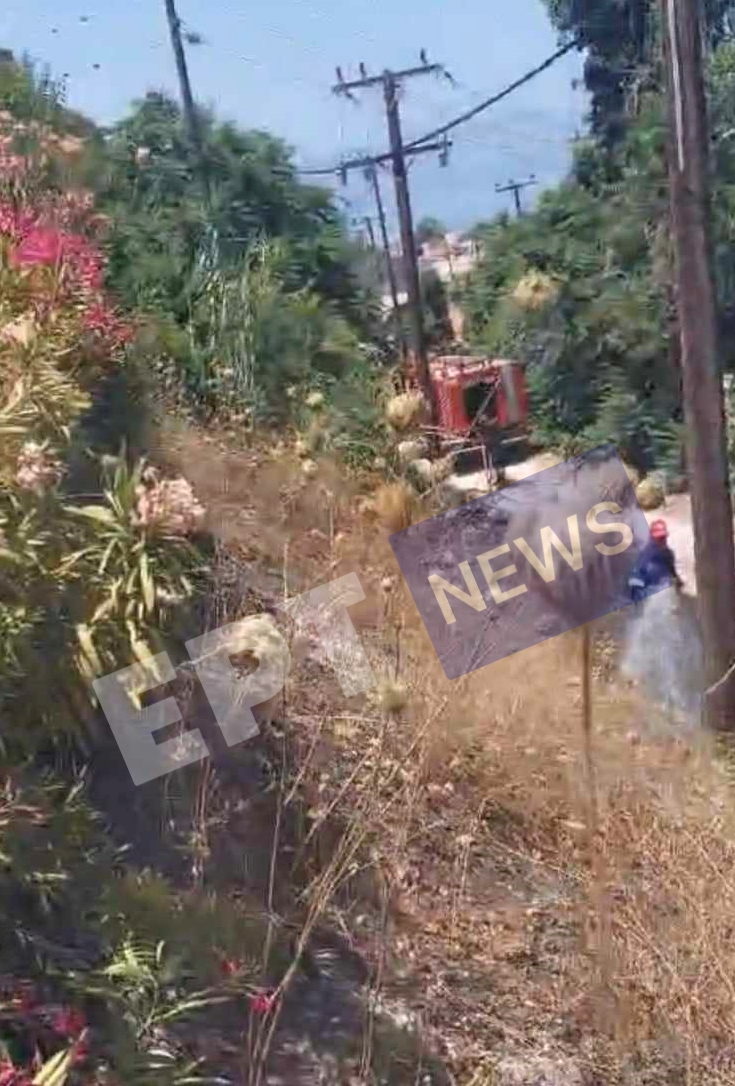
[332,57,451,428]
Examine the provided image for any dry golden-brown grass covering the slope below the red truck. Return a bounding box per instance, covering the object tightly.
[160,417,735,1086]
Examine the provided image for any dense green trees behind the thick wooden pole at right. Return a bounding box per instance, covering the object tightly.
[462,0,735,484]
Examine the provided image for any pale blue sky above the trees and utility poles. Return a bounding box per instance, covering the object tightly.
[0,0,586,228]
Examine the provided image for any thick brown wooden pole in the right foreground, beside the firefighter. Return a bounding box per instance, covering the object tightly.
[661,0,735,730]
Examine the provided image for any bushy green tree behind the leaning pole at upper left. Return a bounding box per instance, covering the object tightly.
[96,92,373,330]
